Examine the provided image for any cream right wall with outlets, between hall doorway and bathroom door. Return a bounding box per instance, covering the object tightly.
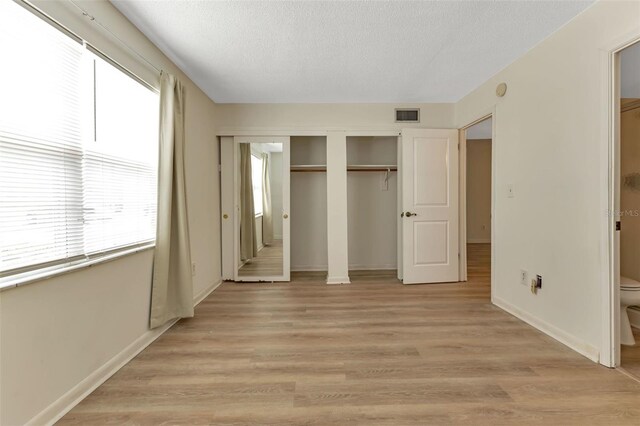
[455,1,640,359]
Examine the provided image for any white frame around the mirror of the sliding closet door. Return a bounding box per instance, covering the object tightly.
[232,136,291,282]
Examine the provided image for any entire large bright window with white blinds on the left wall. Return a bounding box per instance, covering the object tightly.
[0,2,159,276]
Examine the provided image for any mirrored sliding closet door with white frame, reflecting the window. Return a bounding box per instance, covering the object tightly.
[233,136,291,282]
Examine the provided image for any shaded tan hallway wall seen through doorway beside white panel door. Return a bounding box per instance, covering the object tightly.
[467,138,491,243]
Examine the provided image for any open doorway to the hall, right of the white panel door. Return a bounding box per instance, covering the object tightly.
[460,115,494,296]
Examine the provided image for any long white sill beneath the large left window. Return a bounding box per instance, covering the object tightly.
[0,243,155,292]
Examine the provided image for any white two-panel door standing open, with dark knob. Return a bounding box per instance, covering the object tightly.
[400,129,459,284]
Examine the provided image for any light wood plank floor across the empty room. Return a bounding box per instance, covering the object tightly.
[60,245,640,426]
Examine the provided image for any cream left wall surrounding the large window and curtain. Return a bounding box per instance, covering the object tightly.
[0,1,220,425]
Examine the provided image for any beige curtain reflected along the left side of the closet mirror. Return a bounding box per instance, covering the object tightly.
[240,143,258,260]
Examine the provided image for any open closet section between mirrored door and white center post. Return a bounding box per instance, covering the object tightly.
[290,136,328,271]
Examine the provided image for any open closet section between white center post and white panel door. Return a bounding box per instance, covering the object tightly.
[347,136,400,283]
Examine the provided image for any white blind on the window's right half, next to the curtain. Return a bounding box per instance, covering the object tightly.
[83,53,159,254]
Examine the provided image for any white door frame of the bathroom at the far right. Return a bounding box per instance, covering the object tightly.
[600,32,640,367]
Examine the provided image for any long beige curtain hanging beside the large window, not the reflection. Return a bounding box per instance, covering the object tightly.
[149,72,193,328]
